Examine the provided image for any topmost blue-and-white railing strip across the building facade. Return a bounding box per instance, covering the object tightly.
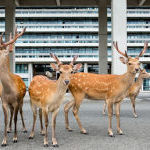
[0,8,150,16]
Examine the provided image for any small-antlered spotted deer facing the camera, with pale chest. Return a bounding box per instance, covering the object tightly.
[29,53,82,147]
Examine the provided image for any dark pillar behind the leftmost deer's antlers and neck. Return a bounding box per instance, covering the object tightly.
[5,0,15,73]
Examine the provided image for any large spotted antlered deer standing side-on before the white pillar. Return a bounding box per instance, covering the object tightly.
[64,42,148,136]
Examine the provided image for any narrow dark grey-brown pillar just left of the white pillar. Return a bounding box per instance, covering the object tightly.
[98,0,108,74]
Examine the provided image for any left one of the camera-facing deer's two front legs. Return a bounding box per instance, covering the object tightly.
[43,110,48,147]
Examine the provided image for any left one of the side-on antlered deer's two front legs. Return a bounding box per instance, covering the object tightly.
[107,102,114,137]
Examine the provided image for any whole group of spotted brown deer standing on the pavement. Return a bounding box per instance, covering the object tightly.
[0,28,150,147]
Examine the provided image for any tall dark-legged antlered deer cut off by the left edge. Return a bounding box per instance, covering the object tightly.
[0,28,26,146]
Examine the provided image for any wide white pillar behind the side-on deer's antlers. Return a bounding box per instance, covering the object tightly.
[111,0,127,74]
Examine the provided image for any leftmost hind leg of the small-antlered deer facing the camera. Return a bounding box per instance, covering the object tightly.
[29,104,37,139]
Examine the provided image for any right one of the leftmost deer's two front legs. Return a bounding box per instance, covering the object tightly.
[13,103,19,143]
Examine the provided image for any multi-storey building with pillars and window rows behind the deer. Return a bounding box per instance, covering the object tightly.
[0,0,150,90]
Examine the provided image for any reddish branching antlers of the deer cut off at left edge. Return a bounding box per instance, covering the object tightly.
[0,27,26,47]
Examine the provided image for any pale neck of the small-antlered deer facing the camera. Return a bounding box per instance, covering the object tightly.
[56,77,68,96]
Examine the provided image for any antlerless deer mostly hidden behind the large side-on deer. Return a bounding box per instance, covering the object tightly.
[103,69,150,118]
